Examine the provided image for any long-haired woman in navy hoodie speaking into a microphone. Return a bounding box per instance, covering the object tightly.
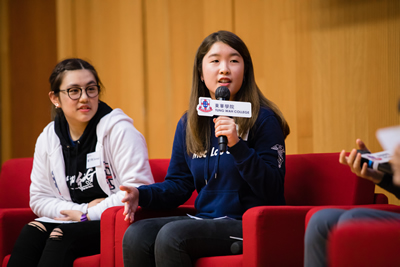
[121,31,289,267]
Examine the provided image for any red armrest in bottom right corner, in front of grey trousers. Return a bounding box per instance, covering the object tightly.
[328,220,400,267]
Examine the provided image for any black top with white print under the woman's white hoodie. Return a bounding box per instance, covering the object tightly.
[54,101,112,204]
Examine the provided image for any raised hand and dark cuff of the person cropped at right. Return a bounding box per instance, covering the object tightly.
[339,139,383,184]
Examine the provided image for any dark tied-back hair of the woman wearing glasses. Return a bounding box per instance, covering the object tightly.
[49,58,103,119]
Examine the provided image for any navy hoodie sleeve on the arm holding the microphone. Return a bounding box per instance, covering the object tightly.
[229,115,285,204]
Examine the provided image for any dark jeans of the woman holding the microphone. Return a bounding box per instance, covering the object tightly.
[123,216,242,267]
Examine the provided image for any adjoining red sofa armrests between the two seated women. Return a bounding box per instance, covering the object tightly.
[101,205,196,267]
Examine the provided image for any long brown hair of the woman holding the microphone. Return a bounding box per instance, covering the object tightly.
[186,31,290,155]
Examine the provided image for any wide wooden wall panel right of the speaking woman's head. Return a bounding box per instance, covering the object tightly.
[234,0,400,153]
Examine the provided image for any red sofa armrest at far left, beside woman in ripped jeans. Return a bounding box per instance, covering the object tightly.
[0,208,37,261]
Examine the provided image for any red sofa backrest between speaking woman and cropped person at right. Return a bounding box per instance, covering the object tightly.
[285,153,375,206]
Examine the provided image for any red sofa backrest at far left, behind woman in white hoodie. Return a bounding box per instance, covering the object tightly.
[0,158,33,208]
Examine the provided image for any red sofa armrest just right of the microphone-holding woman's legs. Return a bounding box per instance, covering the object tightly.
[243,206,314,267]
